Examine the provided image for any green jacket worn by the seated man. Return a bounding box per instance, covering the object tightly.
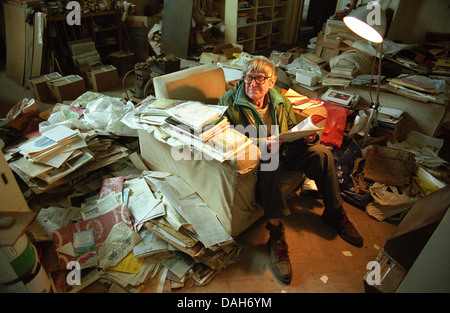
[219,81,297,139]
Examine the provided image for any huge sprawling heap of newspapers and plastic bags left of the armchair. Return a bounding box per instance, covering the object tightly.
[4,92,240,292]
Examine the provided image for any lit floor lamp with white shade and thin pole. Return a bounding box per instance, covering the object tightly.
[344,1,386,148]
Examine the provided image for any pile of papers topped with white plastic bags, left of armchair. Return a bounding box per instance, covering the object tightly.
[3,92,140,194]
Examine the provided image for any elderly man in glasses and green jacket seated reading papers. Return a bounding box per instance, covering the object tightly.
[219,57,363,284]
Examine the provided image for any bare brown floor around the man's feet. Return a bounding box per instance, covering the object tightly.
[140,190,396,293]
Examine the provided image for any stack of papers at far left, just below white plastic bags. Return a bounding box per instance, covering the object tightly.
[6,126,130,194]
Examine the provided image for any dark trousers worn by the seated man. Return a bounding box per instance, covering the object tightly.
[256,142,345,218]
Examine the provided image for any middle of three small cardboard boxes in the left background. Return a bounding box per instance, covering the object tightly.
[47,75,86,103]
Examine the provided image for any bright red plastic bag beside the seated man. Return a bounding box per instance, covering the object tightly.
[312,98,351,148]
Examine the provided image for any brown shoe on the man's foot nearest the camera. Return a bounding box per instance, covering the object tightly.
[267,223,292,285]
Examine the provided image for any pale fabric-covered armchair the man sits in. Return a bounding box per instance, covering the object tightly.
[139,64,302,237]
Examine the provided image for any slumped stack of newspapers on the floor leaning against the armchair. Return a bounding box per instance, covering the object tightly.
[103,171,240,289]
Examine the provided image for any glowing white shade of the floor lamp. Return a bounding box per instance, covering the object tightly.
[344,2,386,43]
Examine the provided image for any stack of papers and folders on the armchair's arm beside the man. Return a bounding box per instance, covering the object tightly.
[166,102,252,162]
